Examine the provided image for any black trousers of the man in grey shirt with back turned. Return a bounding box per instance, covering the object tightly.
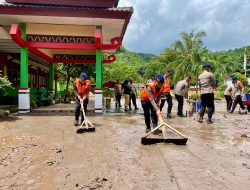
[200,93,215,120]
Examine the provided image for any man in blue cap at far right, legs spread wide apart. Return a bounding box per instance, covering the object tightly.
[230,77,247,113]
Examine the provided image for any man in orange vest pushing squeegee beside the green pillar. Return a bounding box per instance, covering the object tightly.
[74,72,91,126]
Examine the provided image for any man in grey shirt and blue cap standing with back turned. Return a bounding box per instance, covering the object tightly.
[198,64,215,124]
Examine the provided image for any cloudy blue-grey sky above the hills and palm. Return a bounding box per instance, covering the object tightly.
[119,0,250,54]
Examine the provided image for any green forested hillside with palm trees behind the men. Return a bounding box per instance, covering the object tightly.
[104,31,250,86]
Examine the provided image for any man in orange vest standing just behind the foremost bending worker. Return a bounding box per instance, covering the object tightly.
[160,70,173,119]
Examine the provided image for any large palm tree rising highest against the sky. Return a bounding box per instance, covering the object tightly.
[158,30,208,89]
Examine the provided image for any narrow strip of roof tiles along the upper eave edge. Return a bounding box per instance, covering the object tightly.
[0,2,133,12]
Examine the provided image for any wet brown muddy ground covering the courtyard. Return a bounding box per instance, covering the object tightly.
[0,102,250,190]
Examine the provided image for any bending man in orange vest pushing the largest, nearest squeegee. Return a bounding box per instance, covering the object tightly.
[140,75,164,133]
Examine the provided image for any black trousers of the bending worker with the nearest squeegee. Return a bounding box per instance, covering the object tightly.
[141,100,158,129]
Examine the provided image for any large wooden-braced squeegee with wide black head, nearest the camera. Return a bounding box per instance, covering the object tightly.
[141,116,188,145]
